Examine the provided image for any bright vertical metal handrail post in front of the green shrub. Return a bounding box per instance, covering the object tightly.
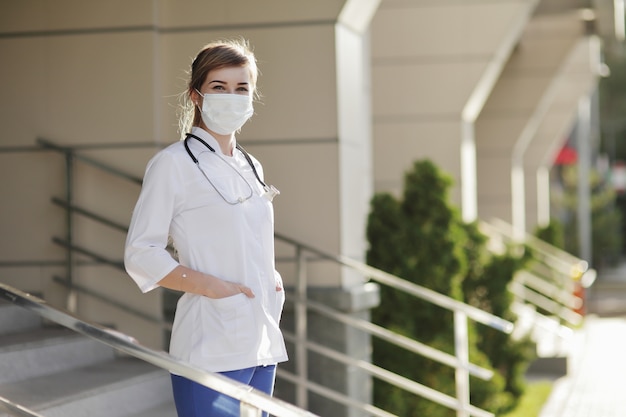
[454,310,470,417]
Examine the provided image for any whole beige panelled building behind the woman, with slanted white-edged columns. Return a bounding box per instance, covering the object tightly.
[0,0,624,415]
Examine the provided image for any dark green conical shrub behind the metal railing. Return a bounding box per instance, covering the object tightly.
[367,160,528,417]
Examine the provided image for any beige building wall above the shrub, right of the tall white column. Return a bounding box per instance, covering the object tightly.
[371,0,606,236]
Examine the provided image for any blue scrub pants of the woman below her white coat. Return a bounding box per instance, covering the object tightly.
[172,365,276,417]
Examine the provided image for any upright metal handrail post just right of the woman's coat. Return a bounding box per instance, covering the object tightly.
[294,245,308,409]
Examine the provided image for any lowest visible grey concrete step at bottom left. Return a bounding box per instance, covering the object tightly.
[0,357,175,417]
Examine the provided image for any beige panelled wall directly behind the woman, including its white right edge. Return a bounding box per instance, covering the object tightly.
[0,0,377,347]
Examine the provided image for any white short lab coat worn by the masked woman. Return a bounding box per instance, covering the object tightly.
[124,128,287,372]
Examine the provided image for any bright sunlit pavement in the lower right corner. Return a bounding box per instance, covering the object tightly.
[539,316,626,417]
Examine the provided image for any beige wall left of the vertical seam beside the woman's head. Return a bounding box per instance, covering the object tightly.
[0,1,160,345]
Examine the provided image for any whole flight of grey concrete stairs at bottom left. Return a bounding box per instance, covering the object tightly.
[0,301,176,417]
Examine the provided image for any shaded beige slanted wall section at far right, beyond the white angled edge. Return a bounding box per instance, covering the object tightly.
[476,11,599,232]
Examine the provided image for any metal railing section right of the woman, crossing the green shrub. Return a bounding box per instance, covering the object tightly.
[276,234,514,417]
